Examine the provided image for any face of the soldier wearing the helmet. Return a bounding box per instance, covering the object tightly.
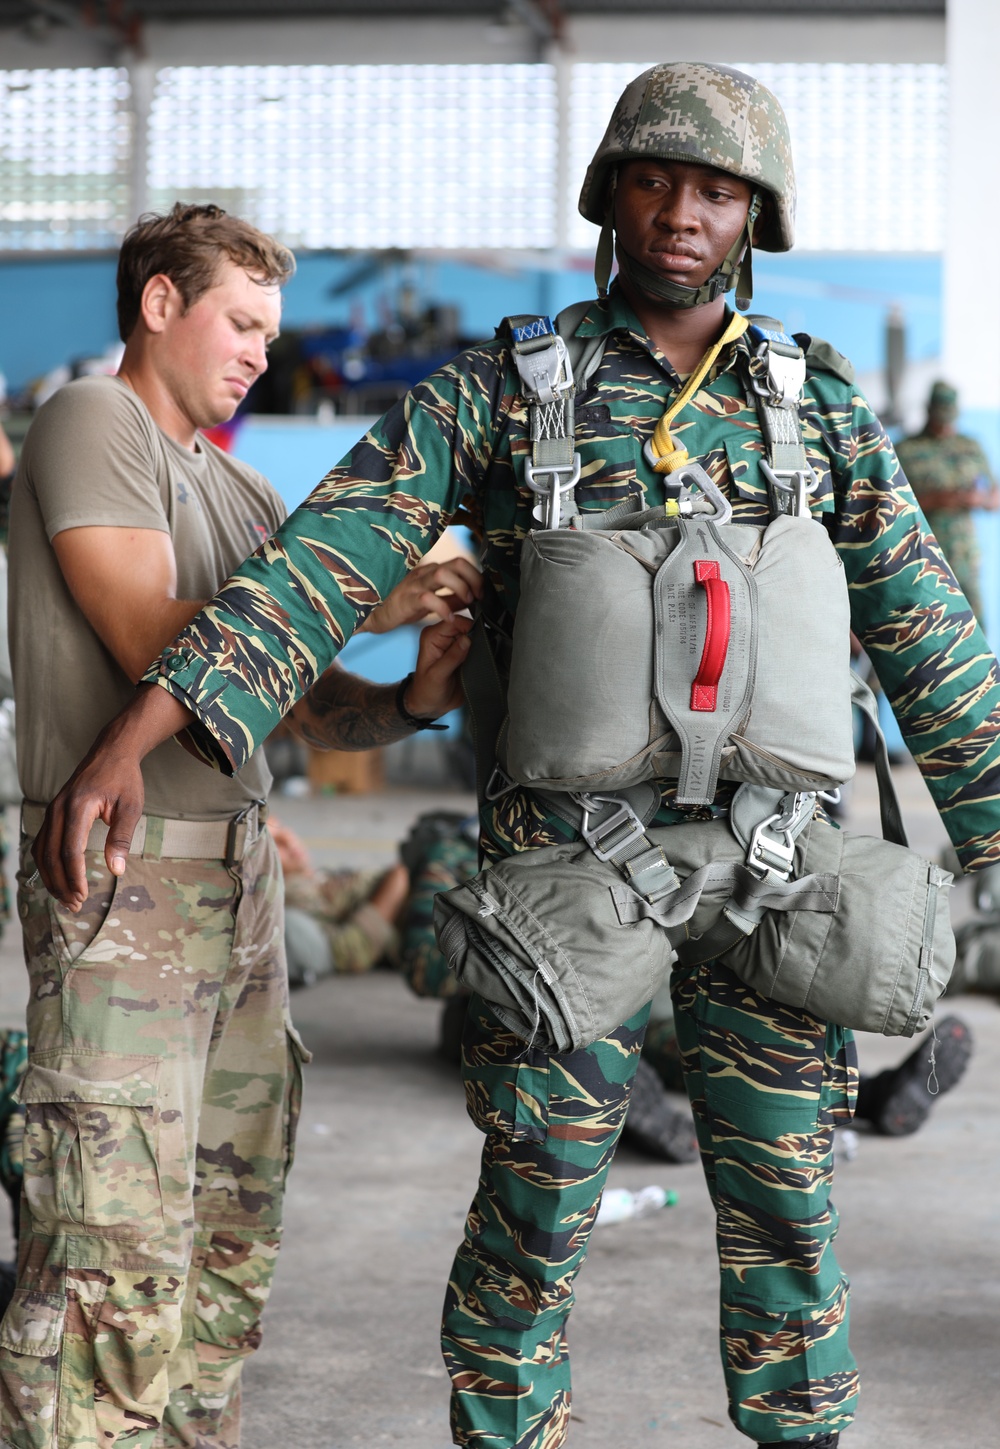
[614,161,752,295]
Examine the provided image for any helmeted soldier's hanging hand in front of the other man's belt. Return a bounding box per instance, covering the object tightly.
[32,684,194,911]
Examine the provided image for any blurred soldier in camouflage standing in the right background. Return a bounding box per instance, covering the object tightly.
[896,383,1000,623]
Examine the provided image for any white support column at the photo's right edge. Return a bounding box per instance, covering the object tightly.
[943,0,1000,649]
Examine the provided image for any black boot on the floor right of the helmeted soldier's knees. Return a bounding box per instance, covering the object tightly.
[857,1016,972,1137]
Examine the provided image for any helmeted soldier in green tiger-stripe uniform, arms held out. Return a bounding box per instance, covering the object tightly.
[29,64,1000,1449]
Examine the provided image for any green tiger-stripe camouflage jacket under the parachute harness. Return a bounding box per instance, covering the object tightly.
[146,288,1000,869]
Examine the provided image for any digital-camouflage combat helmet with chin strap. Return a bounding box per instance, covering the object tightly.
[580,61,796,306]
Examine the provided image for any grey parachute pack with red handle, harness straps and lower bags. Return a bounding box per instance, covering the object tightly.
[435,304,955,1052]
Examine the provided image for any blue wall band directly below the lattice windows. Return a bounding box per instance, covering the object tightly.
[0,252,941,388]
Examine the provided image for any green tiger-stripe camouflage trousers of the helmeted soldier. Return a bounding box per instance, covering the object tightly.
[442,962,857,1449]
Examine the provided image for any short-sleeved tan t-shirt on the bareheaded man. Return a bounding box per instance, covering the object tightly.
[9,377,286,820]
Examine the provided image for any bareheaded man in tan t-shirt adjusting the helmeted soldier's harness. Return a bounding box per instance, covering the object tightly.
[0,206,475,1449]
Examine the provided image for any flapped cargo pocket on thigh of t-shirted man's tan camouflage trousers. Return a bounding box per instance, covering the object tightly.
[19,1053,164,1242]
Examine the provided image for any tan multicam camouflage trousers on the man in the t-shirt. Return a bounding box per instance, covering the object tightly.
[0,830,303,1449]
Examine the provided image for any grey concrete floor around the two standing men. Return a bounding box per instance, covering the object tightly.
[0,768,1000,1449]
